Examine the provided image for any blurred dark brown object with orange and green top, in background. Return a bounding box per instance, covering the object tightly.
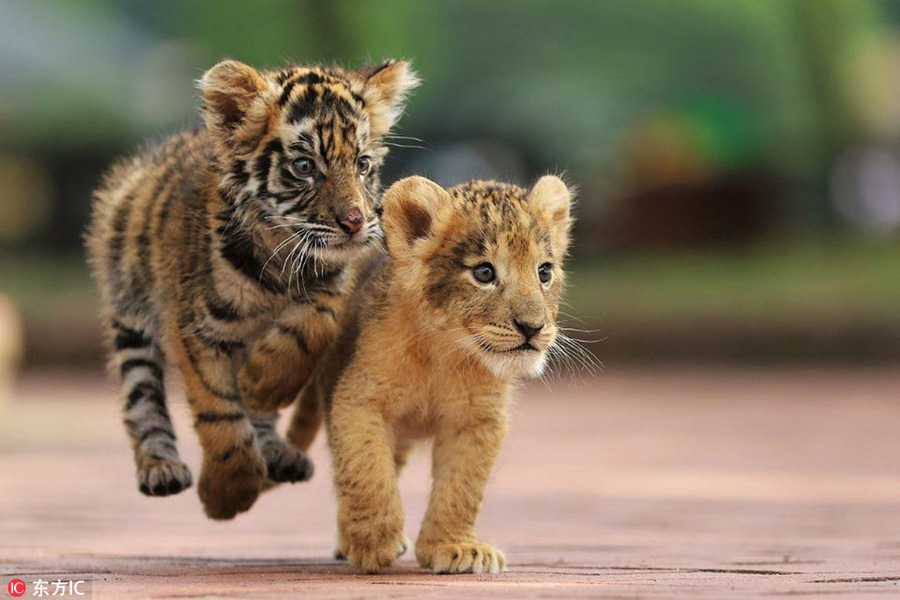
[608,97,784,249]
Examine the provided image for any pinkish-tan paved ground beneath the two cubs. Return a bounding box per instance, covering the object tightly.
[0,368,900,598]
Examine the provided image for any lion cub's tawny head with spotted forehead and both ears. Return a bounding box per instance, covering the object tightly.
[383,175,571,377]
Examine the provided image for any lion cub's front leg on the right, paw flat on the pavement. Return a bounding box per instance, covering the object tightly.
[416,413,506,573]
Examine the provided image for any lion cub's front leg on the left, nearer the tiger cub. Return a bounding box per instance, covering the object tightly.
[329,392,406,573]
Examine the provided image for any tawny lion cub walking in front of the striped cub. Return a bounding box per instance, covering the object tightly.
[291,176,571,573]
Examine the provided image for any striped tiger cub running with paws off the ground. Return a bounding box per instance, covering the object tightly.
[87,60,417,519]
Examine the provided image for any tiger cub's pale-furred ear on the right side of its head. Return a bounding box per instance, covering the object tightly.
[359,60,419,138]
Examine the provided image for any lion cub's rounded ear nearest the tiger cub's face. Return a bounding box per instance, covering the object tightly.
[381,177,450,258]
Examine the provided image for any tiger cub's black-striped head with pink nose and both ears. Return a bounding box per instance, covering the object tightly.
[200,60,418,261]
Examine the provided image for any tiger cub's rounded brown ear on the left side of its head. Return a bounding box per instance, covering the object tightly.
[200,60,269,148]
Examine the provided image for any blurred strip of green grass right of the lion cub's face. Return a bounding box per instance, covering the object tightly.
[568,238,900,328]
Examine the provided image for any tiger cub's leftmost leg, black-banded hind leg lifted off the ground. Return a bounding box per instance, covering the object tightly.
[112,321,192,496]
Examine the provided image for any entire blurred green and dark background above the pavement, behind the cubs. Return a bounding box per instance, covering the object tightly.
[0,0,900,364]
